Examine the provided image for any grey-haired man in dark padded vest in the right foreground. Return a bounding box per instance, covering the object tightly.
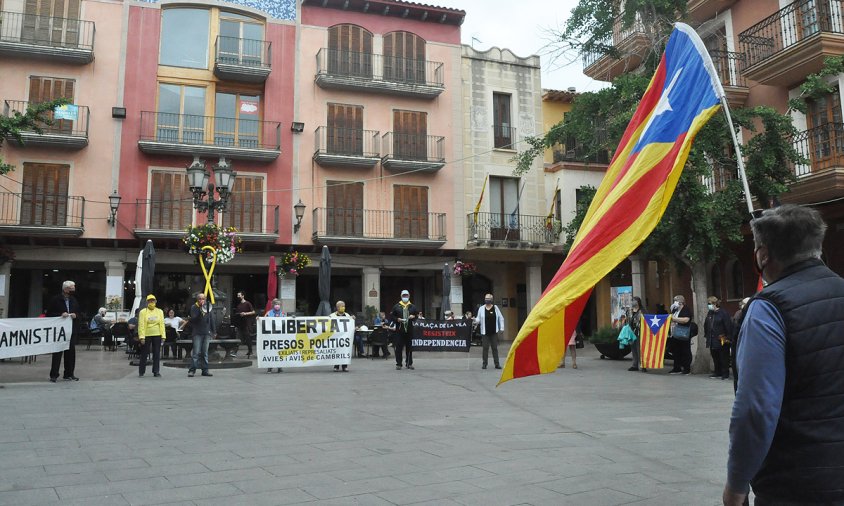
[723,205,844,505]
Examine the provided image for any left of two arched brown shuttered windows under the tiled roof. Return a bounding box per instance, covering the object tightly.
[328,25,372,78]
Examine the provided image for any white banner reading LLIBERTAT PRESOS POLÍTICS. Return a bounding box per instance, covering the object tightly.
[256,316,355,368]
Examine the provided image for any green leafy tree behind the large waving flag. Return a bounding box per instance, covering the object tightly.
[516,0,801,373]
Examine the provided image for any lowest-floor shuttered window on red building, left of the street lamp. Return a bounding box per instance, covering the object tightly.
[147,171,193,230]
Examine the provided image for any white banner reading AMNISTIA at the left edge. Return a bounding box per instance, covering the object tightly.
[0,316,73,358]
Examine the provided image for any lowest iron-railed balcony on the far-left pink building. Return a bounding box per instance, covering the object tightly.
[0,192,85,237]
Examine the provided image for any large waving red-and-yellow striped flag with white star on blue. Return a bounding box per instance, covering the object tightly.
[499,23,724,384]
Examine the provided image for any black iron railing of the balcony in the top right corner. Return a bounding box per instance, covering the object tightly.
[739,0,844,68]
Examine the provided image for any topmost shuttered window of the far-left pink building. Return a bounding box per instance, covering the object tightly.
[21,0,80,47]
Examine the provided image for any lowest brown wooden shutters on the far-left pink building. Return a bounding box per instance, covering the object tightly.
[20,162,70,227]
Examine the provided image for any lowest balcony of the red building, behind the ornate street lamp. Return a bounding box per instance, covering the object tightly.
[133,199,279,242]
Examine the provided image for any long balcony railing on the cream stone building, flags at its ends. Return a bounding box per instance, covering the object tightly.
[466,213,562,250]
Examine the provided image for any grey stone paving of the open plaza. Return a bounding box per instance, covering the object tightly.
[0,345,732,506]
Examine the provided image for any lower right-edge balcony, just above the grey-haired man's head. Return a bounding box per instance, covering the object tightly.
[782,123,844,204]
